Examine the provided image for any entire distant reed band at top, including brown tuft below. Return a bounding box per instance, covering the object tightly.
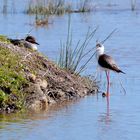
[25,0,92,26]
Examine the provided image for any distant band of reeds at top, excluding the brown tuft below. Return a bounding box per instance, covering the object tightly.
[26,0,92,15]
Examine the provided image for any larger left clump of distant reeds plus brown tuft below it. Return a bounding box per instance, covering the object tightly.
[26,0,71,26]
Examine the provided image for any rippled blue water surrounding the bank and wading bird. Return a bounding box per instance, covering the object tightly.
[0,0,140,140]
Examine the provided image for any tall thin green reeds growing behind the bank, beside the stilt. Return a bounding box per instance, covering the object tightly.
[58,16,97,74]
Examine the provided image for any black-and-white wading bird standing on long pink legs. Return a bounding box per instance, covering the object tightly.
[96,43,125,103]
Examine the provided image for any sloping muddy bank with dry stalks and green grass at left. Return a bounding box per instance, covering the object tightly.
[0,38,97,112]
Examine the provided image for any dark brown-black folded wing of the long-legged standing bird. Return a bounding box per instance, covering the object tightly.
[98,54,125,74]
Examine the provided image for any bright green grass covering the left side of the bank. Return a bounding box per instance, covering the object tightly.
[0,46,27,109]
